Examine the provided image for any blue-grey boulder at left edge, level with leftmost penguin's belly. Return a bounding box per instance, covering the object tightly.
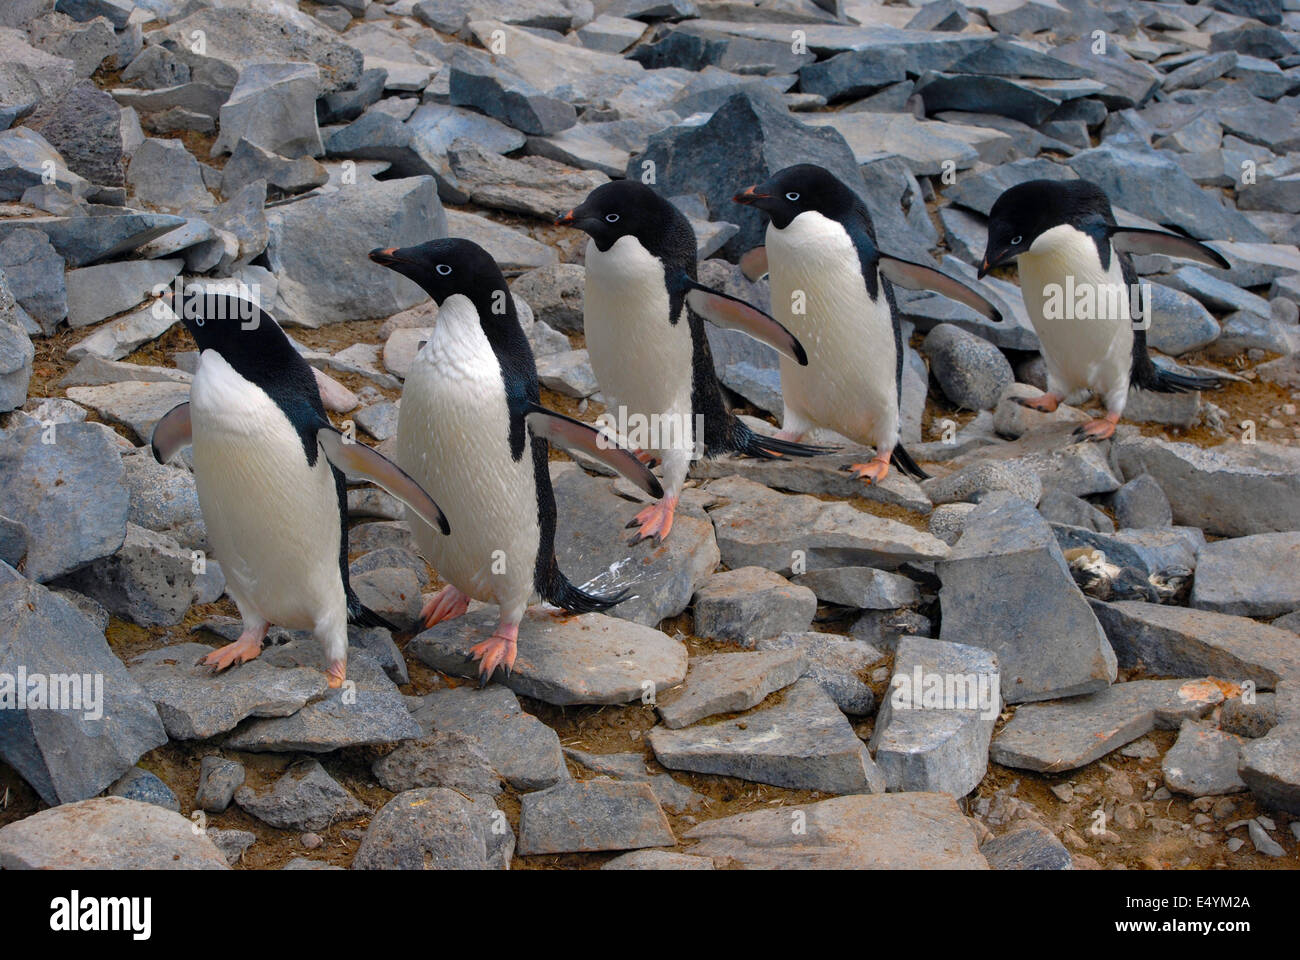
[0,423,129,581]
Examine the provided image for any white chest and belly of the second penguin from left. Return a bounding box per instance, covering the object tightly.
[397,295,541,614]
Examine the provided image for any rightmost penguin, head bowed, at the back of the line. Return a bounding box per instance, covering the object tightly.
[979,180,1229,440]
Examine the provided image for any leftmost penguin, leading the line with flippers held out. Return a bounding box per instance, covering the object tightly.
[150,285,450,688]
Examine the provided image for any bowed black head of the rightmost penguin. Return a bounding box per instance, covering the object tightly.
[979,180,1114,277]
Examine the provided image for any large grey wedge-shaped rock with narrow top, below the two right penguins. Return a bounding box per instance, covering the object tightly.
[935,494,1115,704]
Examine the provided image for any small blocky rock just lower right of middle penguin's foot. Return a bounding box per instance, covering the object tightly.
[694,567,816,645]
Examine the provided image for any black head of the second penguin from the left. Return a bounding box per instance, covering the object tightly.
[371,237,515,319]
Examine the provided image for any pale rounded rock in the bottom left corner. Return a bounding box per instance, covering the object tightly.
[0,796,229,870]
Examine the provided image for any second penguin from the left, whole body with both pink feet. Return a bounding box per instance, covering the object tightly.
[371,238,663,684]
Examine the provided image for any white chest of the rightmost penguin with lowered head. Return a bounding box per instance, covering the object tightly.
[1018,224,1134,398]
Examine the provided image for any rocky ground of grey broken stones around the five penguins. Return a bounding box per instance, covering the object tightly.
[0,0,1300,869]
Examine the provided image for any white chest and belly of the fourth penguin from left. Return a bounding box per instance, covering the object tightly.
[767,212,898,450]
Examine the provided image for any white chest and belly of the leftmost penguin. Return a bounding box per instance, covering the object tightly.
[190,350,347,630]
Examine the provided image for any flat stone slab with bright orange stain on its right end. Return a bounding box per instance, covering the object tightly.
[989,679,1223,773]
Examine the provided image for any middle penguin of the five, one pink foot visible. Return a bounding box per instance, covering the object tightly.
[556,180,827,544]
